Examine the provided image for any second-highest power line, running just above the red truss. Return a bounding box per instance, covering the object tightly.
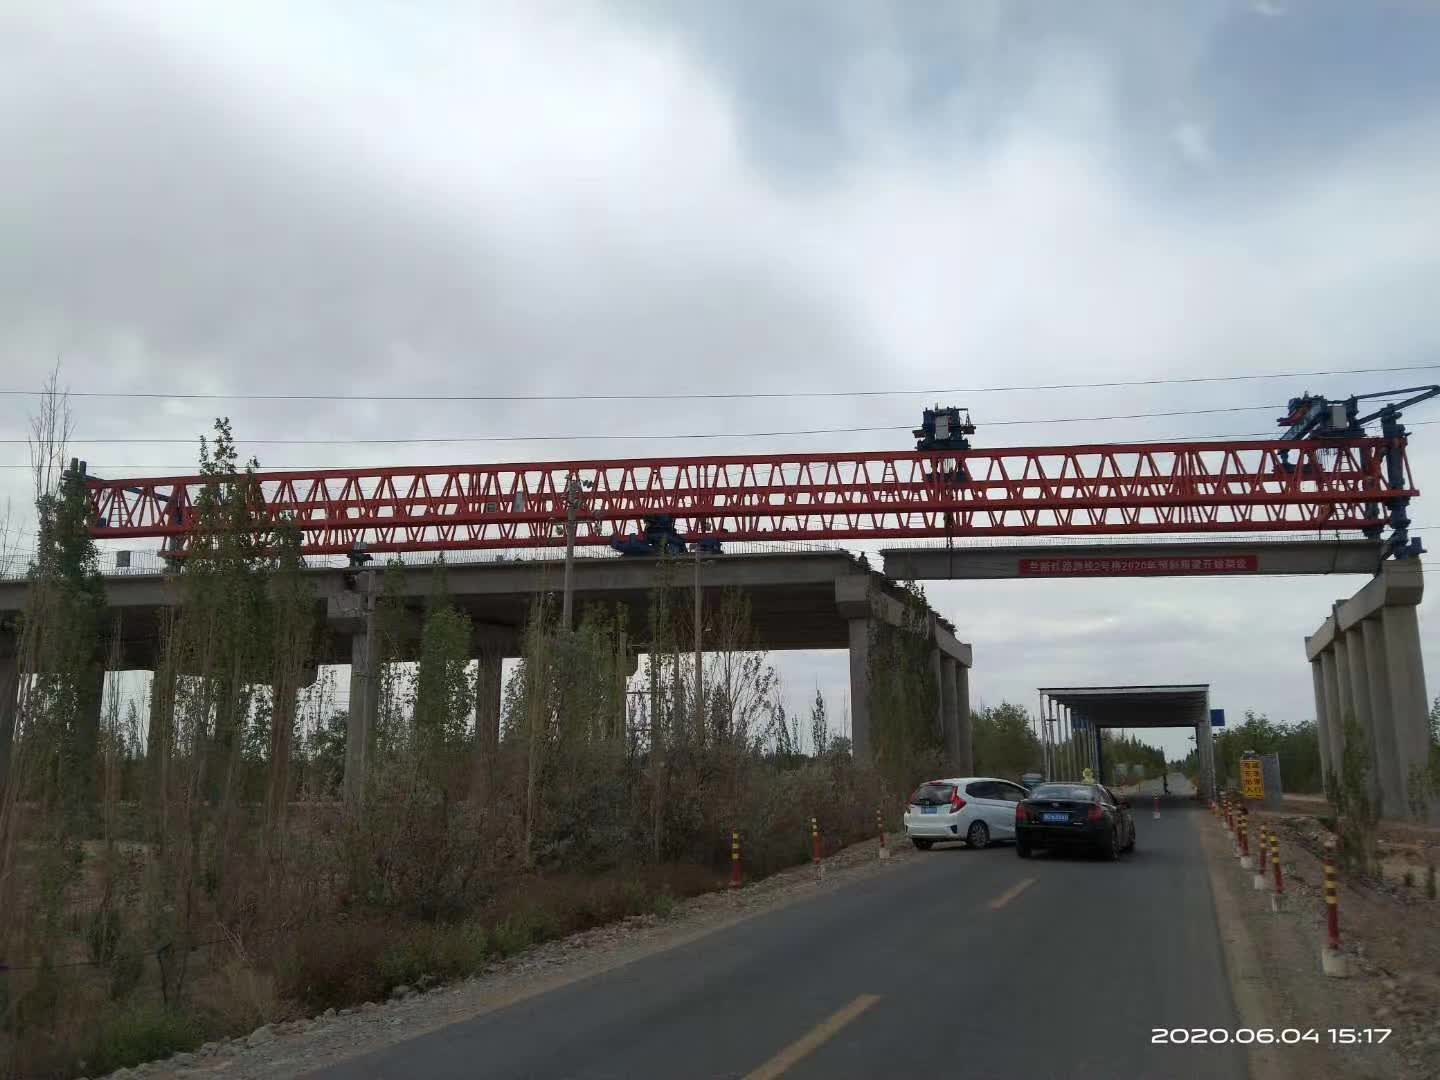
[0,405,1284,446]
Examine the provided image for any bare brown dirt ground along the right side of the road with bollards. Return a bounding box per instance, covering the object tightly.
[1198,801,1440,1080]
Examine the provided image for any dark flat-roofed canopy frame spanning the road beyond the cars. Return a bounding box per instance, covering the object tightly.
[1040,683,1215,796]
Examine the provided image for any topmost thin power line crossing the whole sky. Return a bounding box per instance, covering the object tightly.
[0,363,1440,402]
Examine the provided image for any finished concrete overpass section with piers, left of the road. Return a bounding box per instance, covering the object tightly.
[0,552,973,800]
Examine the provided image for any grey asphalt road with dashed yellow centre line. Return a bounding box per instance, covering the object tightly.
[317,804,1246,1080]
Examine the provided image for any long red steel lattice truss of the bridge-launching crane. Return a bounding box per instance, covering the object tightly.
[89,439,1418,554]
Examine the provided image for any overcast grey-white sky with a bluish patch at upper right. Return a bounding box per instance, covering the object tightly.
[0,0,1440,750]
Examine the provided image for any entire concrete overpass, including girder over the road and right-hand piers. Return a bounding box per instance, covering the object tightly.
[0,536,1434,818]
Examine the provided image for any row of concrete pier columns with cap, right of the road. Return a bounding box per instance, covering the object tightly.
[1305,559,1440,822]
